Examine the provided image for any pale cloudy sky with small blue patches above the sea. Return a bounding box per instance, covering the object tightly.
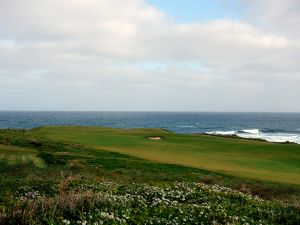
[0,0,300,111]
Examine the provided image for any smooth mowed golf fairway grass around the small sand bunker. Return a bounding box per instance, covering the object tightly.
[31,127,300,185]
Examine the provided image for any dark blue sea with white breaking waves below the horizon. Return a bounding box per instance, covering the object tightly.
[0,111,300,144]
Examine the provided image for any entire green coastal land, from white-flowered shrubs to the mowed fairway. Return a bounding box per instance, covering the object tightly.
[0,127,300,224]
